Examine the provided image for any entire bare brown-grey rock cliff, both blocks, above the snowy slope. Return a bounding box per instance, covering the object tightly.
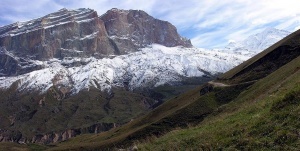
[0,9,192,76]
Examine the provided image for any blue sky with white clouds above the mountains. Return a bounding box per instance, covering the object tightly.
[0,0,300,48]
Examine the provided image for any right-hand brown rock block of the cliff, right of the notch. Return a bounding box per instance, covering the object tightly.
[100,8,192,53]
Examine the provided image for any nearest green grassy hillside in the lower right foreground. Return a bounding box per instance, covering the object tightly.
[138,57,300,150]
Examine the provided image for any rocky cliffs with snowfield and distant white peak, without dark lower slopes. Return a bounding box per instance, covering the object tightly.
[0,9,289,94]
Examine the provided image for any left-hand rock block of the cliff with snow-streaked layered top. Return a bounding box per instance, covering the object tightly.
[0,9,114,60]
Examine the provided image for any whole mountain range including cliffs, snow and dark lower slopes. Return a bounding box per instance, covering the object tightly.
[0,8,289,144]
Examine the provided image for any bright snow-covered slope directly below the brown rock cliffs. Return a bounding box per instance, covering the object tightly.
[0,44,248,93]
